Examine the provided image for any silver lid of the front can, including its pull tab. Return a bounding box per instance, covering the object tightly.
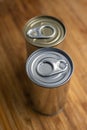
[26,48,73,88]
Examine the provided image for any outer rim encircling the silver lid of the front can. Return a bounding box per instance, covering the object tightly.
[26,47,74,89]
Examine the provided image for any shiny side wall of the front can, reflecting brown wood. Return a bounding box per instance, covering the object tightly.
[29,81,70,115]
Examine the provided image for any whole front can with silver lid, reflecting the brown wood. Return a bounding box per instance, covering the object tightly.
[26,48,73,115]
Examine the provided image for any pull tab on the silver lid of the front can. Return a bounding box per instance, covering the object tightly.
[37,59,68,77]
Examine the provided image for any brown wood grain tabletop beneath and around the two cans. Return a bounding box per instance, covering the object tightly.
[0,0,87,130]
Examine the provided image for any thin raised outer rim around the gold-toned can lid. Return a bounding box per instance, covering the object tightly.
[23,15,67,47]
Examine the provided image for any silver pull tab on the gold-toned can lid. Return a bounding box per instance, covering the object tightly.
[27,25,56,39]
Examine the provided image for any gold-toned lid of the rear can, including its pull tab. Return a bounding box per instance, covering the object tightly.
[24,16,66,47]
